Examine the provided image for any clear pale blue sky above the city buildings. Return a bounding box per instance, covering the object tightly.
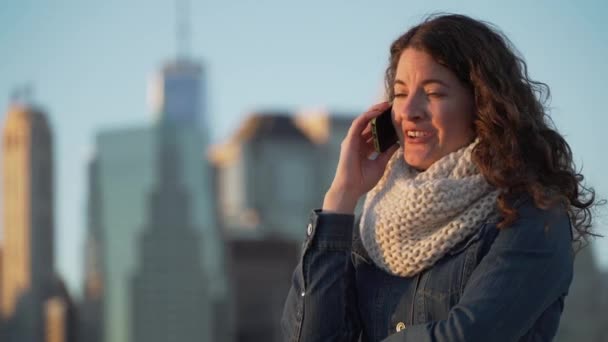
[0,0,608,293]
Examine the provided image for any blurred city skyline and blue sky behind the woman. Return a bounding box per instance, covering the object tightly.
[0,0,608,342]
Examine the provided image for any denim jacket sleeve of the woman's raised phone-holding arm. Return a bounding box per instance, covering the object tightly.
[281,210,360,342]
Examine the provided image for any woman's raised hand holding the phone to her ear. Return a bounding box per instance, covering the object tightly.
[323,102,399,214]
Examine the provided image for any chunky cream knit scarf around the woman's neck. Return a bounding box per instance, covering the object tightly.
[359,141,498,277]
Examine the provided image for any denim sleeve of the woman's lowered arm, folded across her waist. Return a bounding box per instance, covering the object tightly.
[384,199,573,342]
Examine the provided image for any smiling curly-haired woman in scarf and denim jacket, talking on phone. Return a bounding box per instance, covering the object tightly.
[282,15,594,342]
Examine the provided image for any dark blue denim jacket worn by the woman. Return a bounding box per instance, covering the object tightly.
[281,199,573,342]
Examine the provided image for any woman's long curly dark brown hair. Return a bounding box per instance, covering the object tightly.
[385,14,597,240]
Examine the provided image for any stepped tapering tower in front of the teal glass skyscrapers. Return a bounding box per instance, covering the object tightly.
[130,124,211,342]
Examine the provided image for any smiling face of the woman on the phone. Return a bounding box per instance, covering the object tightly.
[393,48,475,170]
